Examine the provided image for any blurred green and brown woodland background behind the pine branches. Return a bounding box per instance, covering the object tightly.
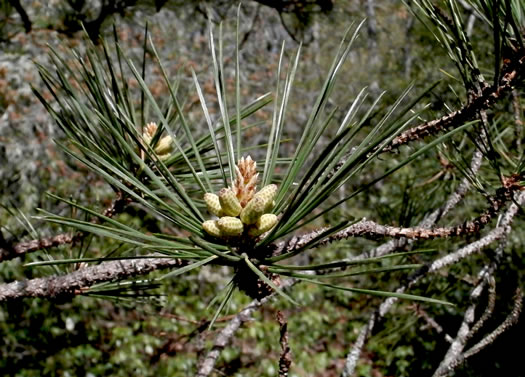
[0,0,525,376]
